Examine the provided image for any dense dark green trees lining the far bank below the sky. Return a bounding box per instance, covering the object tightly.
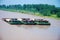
[0,4,60,17]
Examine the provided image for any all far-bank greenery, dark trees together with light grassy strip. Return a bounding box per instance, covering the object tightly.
[0,4,60,18]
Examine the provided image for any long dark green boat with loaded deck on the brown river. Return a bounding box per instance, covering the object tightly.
[3,18,50,25]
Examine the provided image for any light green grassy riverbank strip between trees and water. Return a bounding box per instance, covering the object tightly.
[0,9,60,20]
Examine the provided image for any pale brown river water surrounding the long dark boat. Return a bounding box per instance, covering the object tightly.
[0,10,60,40]
